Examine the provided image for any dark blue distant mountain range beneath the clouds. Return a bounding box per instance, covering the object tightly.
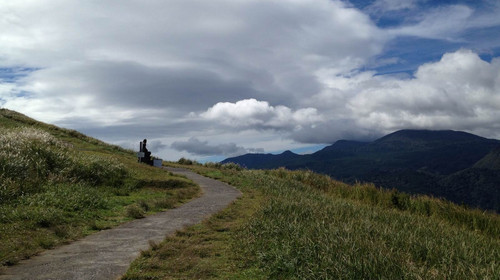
[222,130,500,212]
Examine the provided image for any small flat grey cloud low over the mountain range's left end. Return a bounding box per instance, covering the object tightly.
[171,137,264,156]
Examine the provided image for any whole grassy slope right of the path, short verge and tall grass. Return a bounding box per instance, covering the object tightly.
[124,164,500,279]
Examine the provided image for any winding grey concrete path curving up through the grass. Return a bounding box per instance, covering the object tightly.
[0,168,241,280]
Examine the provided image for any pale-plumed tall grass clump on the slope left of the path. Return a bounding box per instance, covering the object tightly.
[0,128,128,203]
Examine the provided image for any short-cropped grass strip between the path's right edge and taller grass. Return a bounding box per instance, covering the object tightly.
[123,176,265,279]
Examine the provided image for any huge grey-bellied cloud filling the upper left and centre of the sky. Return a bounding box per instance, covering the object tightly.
[0,0,386,122]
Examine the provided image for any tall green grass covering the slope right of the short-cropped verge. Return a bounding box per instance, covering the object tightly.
[238,170,500,279]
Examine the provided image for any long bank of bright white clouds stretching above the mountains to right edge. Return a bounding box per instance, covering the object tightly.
[192,49,500,143]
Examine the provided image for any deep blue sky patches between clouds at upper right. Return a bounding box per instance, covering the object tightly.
[349,0,500,75]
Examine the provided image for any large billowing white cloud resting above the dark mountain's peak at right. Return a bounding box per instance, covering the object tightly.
[347,50,500,137]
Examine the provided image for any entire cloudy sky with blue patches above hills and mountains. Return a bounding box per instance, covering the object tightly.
[0,0,500,162]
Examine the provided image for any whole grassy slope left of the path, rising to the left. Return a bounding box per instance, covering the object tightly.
[0,109,199,265]
